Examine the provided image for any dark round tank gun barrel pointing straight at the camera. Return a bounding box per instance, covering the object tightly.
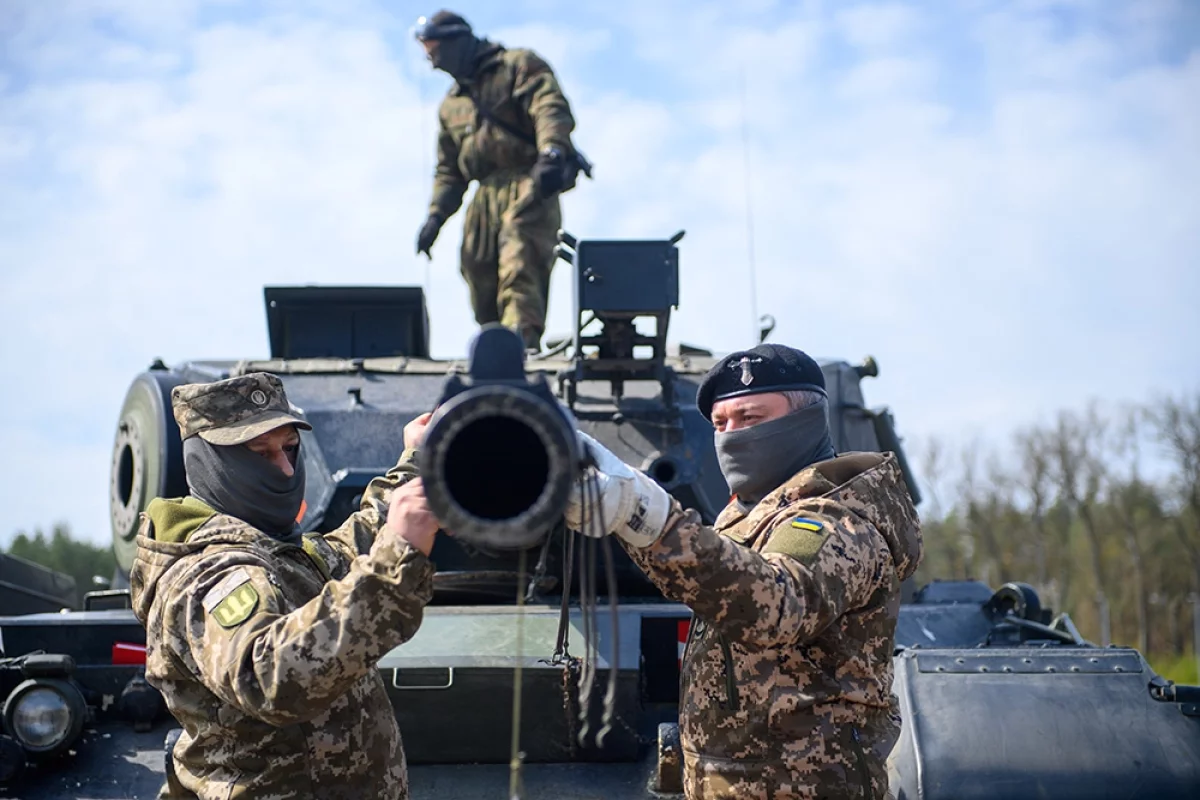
[419,325,580,549]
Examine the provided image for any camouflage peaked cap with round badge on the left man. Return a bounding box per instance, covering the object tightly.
[170,372,312,445]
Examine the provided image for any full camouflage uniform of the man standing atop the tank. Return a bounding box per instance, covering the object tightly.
[430,44,575,343]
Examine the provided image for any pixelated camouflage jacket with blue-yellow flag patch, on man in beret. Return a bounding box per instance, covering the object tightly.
[626,453,922,800]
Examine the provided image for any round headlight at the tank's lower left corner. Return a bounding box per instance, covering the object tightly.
[4,678,88,756]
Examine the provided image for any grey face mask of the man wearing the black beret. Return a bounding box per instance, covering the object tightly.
[714,399,834,506]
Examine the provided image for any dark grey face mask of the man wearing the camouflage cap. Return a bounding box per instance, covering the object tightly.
[184,437,305,541]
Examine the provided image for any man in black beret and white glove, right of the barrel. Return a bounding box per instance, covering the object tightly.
[566,344,922,800]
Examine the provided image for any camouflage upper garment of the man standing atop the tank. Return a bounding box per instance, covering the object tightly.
[430,44,575,218]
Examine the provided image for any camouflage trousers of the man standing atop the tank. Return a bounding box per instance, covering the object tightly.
[461,170,563,347]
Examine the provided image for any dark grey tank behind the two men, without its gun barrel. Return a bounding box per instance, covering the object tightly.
[0,234,1200,800]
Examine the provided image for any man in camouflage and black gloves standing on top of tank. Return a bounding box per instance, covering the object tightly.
[415,11,580,350]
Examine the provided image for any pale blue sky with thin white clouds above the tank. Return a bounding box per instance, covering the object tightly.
[0,0,1200,546]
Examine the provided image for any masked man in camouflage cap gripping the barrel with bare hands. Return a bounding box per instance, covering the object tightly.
[130,373,438,800]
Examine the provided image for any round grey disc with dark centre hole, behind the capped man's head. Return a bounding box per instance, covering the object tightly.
[108,372,187,577]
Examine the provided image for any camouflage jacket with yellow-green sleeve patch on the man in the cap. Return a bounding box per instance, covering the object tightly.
[130,451,433,800]
